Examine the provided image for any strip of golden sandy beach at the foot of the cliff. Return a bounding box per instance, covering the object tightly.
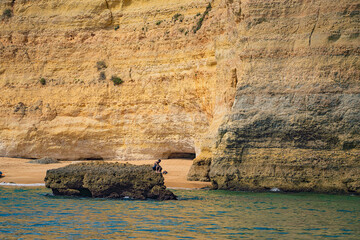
[0,157,210,188]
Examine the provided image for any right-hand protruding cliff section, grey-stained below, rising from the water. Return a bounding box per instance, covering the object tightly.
[189,0,360,193]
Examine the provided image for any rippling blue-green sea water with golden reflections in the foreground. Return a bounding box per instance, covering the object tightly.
[0,187,360,239]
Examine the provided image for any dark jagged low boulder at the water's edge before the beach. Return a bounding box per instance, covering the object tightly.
[45,163,176,200]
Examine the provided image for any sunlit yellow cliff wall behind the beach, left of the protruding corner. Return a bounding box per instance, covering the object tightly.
[0,0,235,159]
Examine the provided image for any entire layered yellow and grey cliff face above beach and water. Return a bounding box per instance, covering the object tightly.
[0,0,360,192]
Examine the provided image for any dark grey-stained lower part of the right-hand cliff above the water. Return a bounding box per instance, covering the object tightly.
[209,94,360,194]
